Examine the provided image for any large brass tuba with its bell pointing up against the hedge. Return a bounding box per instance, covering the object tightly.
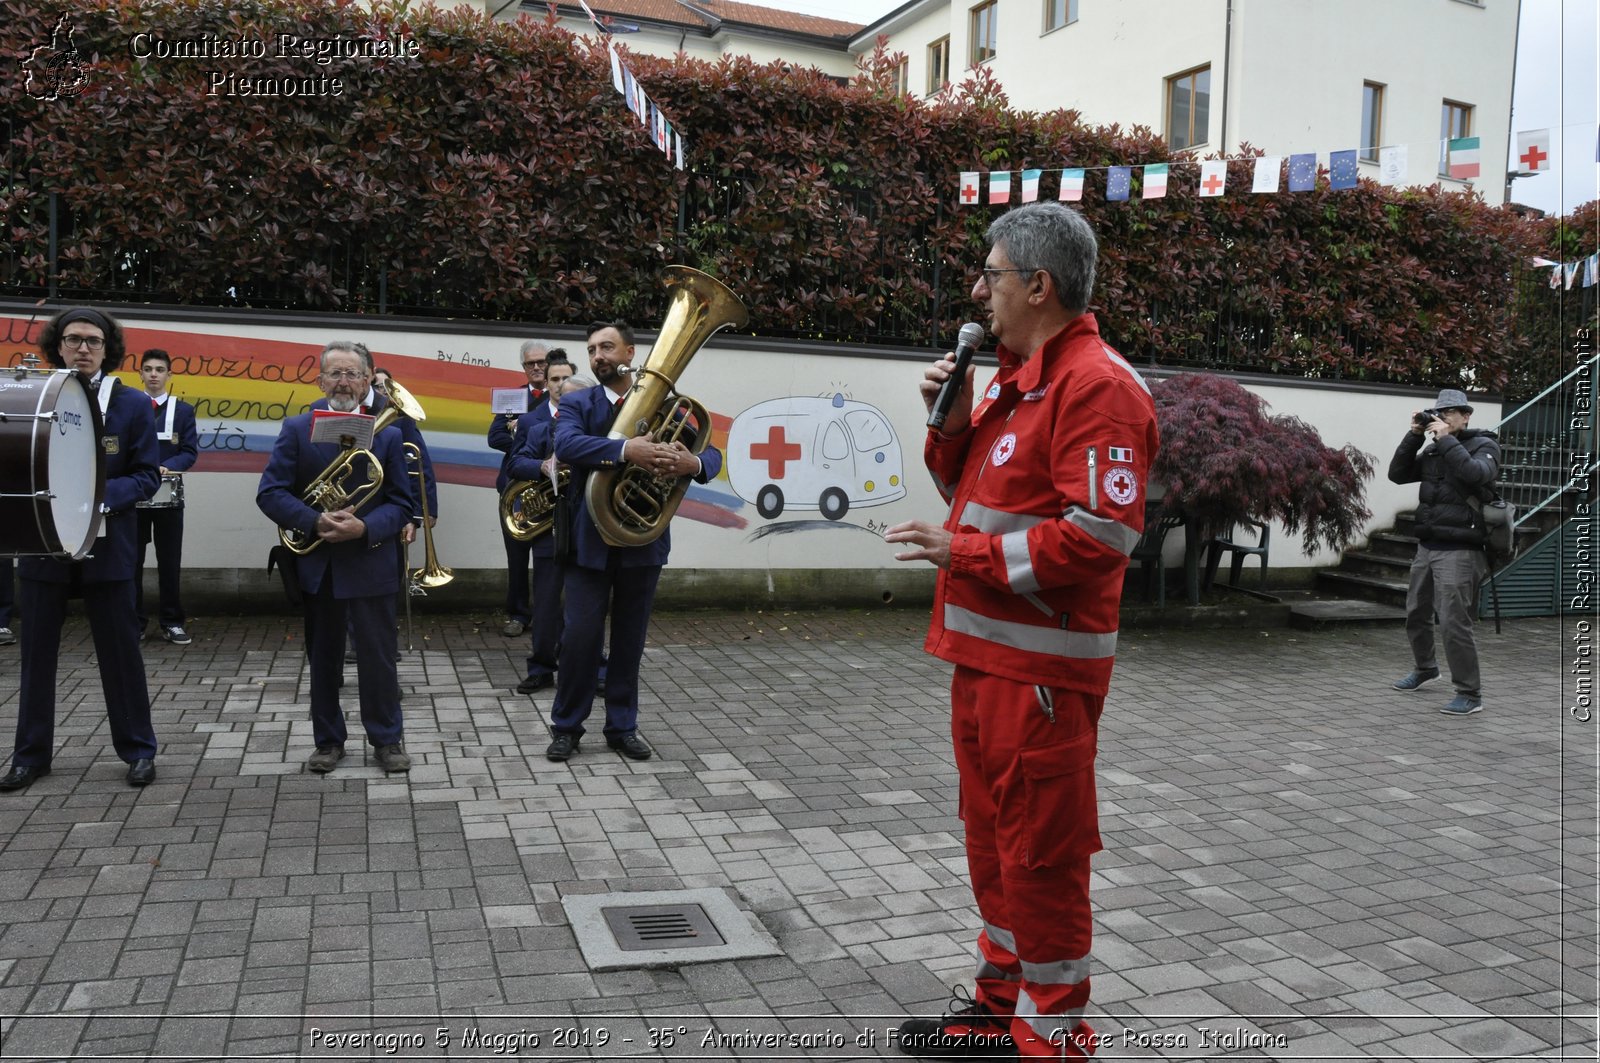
[584,266,749,546]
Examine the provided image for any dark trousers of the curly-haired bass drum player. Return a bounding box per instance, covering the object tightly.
[11,580,155,767]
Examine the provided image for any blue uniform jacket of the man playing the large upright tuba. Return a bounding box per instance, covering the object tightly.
[554,377,722,568]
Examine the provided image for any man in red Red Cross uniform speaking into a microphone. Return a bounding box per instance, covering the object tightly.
[885,203,1157,1058]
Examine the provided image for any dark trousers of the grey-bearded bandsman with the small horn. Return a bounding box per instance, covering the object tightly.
[306,580,405,746]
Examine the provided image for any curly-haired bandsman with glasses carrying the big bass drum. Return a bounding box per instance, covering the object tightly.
[0,307,160,791]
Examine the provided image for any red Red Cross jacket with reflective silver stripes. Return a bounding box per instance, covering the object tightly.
[925,314,1158,696]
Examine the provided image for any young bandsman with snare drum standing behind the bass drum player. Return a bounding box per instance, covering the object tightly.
[133,347,200,645]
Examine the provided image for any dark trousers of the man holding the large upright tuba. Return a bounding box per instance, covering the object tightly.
[550,552,661,738]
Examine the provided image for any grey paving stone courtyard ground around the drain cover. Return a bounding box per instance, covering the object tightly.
[0,610,1600,1060]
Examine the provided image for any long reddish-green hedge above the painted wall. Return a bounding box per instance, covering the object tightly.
[0,0,1568,387]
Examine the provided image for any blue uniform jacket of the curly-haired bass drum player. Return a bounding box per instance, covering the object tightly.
[16,381,162,583]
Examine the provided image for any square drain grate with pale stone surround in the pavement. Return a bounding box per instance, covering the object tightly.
[562,887,782,970]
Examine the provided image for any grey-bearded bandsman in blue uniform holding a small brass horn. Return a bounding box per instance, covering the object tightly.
[256,341,411,773]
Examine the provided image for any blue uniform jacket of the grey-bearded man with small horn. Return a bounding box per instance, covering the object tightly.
[256,413,411,599]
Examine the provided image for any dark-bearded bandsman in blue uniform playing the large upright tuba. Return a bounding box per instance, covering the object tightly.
[544,322,722,760]
